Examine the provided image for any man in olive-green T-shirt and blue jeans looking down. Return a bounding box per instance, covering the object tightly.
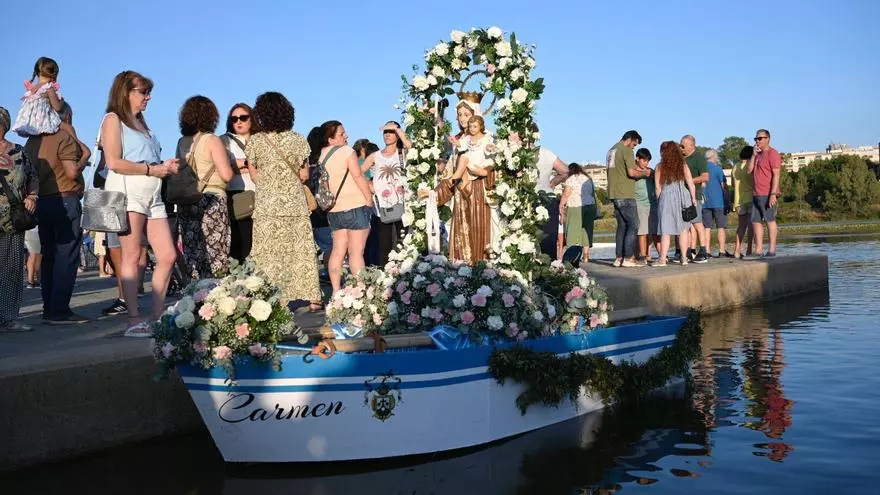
[606,131,650,267]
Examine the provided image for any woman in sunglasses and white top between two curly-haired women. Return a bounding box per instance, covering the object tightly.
[220,103,256,262]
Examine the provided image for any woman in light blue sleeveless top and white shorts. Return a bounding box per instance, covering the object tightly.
[100,71,177,337]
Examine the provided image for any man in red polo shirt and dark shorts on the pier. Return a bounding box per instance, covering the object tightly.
[749,129,782,258]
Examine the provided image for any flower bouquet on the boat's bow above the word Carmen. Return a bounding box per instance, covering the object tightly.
[153,259,308,379]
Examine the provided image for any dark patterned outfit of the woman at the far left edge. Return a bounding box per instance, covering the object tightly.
[0,144,37,327]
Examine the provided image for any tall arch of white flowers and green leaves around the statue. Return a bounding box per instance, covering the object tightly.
[401,27,549,274]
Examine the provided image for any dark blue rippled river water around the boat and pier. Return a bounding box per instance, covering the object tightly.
[0,236,880,495]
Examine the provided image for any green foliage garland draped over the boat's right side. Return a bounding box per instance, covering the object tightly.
[489,311,703,414]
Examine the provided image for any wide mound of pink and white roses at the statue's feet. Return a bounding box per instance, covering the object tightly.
[327,253,612,344]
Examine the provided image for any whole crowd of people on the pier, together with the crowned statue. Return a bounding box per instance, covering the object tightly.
[0,57,779,337]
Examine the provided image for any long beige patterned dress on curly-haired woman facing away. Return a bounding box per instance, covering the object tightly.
[245,131,321,301]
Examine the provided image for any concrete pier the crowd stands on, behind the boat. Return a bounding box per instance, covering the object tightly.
[0,255,828,470]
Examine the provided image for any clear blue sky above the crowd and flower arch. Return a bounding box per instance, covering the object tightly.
[0,0,880,167]
